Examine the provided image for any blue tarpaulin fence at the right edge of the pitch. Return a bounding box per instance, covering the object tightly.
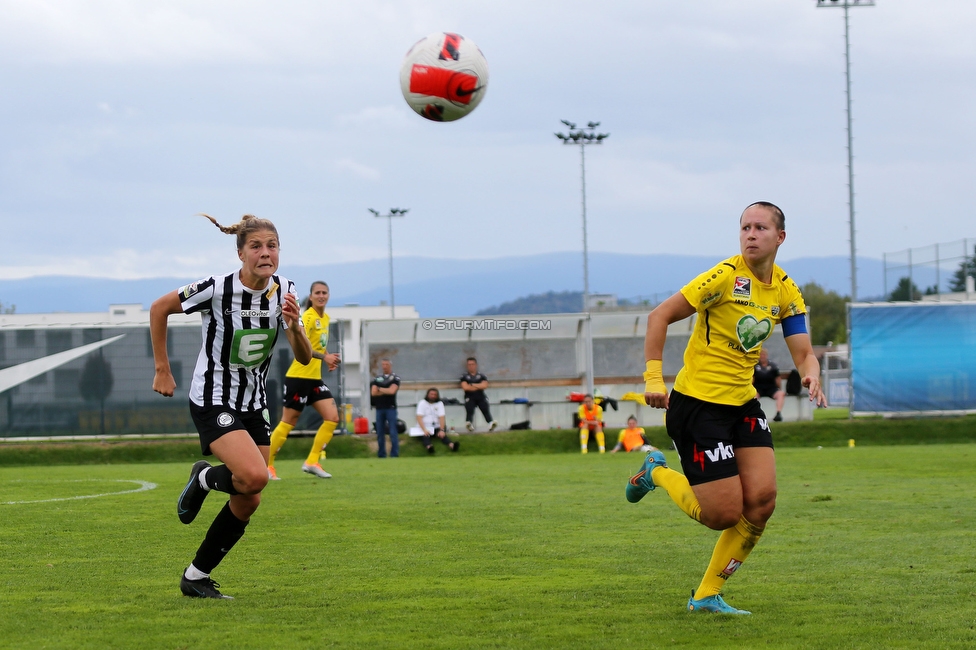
[849,302,976,413]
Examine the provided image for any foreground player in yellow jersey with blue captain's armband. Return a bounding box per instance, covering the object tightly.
[627,201,826,614]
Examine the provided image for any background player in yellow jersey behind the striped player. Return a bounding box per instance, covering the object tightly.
[268,282,340,481]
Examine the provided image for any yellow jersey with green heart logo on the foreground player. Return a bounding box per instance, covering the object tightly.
[674,255,806,406]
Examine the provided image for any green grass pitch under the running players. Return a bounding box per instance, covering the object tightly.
[0,445,976,649]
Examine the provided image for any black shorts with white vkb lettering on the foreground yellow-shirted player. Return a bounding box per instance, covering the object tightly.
[665,390,773,485]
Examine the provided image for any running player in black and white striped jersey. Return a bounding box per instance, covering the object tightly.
[149,215,312,598]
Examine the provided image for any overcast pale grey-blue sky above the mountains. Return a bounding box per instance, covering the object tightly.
[0,0,976,278]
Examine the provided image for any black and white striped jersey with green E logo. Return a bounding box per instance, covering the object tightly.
[178,271,301,411]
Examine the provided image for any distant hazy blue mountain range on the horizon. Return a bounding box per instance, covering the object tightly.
[0,253,883,318]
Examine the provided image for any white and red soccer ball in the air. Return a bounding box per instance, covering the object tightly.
[400,32,488,122]
